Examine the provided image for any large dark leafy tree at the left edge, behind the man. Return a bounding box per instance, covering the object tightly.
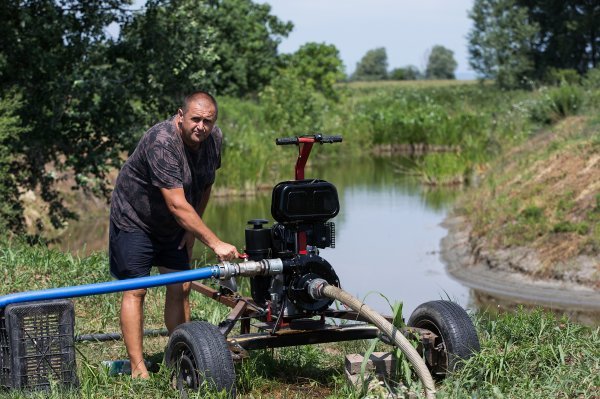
[0,0,131,230]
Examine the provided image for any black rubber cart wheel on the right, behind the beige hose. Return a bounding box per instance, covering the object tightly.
[408,300,480,379]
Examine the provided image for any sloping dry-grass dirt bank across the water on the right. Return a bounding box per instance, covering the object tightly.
[442,115,600,321]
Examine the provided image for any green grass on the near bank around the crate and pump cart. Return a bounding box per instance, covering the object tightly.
[0,239,600,399]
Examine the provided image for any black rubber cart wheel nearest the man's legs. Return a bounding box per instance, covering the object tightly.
[165,321,236,398]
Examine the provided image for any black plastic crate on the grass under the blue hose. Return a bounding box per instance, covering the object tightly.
[0,300,78,390]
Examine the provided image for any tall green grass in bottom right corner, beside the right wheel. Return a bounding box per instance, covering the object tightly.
[438,309,600,399]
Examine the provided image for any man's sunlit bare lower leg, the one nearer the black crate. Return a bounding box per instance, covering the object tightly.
[121,288,149,378]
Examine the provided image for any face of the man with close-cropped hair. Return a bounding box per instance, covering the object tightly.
[177,100,217,150]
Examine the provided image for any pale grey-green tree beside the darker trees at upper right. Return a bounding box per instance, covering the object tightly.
[467,0,539,88]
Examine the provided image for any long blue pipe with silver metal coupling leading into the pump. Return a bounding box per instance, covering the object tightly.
[0,259,283,309]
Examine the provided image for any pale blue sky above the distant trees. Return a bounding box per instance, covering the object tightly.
[255,0,475,79]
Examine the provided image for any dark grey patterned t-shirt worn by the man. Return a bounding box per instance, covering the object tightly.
[110,119,223,240]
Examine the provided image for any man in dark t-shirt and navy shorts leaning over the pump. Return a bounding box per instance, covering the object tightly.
[109,91,239,378]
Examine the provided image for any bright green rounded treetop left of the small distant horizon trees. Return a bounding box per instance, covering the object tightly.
[284,43,345,99]
